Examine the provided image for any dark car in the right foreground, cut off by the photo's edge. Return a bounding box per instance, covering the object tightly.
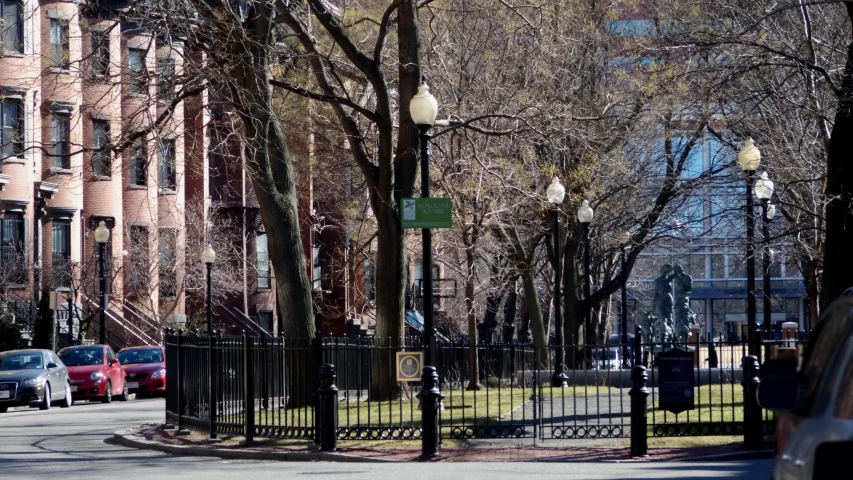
[758,290,853,480]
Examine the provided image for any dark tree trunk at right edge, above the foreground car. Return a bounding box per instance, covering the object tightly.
[812,11,853,312]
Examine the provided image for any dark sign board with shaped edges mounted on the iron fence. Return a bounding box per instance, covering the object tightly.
[658,348,696,414]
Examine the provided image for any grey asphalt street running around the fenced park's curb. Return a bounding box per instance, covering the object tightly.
[0,399,771,480]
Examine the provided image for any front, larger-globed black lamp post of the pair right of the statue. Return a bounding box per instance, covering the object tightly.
[738,138,761,356]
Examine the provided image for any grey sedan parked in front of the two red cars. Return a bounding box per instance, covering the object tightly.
[0,350,73,413]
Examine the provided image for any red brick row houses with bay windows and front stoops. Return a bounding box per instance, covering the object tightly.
[0,0,376,343]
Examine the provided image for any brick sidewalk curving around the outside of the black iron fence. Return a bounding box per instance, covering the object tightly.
[115,425,773,462]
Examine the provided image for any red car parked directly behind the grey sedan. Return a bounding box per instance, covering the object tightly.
[59,345,129,403]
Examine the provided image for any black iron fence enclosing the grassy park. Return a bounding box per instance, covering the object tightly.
[165,326,801,454]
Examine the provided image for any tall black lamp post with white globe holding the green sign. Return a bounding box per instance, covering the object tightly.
[409,83,438,366]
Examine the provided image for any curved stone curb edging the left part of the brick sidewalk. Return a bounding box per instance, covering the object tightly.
[113,430,398,463]
